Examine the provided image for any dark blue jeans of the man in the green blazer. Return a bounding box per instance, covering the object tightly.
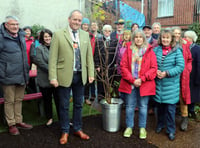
[58,72,84,133]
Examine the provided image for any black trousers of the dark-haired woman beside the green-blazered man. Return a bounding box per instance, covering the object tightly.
[40,87,59,119]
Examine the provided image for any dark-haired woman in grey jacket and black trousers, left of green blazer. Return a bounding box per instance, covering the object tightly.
[35,29,59,126]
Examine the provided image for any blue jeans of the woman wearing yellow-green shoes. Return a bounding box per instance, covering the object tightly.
[125,88,149,128]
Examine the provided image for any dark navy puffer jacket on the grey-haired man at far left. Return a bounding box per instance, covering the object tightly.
[0,23,29,85]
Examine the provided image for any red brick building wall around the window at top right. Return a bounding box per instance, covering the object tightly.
[124,0,197,28]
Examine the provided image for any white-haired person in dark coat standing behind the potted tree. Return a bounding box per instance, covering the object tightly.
[94,24,118,101]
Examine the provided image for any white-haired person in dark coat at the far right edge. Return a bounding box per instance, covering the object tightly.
[184,30,200,119]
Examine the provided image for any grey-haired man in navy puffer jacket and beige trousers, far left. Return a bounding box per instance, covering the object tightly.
[0,16,32,135]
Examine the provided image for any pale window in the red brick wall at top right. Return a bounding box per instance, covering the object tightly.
[158,0,174,17]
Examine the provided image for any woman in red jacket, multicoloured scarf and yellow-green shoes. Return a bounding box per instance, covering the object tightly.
[119,29,157,139]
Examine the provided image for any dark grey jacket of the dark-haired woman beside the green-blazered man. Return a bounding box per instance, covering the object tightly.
[34,45,51,88]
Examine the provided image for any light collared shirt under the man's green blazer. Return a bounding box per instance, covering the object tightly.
[68,26,80,71]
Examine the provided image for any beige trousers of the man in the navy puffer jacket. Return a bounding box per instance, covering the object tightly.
[2,85,25,126]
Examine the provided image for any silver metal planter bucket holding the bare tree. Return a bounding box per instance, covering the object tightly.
[100,98,123,132]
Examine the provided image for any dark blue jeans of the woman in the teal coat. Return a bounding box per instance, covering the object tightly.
[156,103,176,134]
